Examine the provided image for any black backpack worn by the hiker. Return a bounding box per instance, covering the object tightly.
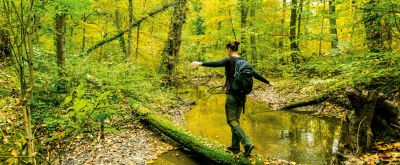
[232,57,254,95]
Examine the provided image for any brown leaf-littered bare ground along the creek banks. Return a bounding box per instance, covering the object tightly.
[59,78,400,164]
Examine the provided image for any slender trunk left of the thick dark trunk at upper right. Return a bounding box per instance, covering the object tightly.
[329,0,339,49]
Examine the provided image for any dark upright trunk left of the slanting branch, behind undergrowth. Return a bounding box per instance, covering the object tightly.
[56,13,66,71]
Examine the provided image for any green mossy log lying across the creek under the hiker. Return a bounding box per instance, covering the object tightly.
[131,103,263,164]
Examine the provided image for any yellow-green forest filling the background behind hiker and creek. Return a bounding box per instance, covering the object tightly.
[0,0,400,164]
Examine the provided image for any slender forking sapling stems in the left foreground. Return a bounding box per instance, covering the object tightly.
[3,0,36,164]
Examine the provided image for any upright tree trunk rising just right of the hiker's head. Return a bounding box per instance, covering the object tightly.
[240,0,249,58]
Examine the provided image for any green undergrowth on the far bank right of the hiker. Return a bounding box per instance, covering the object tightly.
[260,52,400,96]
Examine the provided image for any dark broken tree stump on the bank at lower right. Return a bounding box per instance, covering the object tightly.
[339,87,400,158]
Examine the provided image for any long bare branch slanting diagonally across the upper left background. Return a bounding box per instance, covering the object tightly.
[81,3,175,56]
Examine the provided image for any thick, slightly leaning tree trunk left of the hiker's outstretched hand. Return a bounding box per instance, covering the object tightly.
[158,0,188,85]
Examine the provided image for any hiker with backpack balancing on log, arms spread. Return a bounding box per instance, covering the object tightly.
[192,41,272,157]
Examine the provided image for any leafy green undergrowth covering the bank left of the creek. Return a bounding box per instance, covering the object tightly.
[0,48,178,164]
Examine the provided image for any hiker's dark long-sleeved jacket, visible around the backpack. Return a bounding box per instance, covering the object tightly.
[202,57,269,93]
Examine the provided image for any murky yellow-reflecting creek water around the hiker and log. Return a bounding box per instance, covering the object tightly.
[156,87,340,164]
